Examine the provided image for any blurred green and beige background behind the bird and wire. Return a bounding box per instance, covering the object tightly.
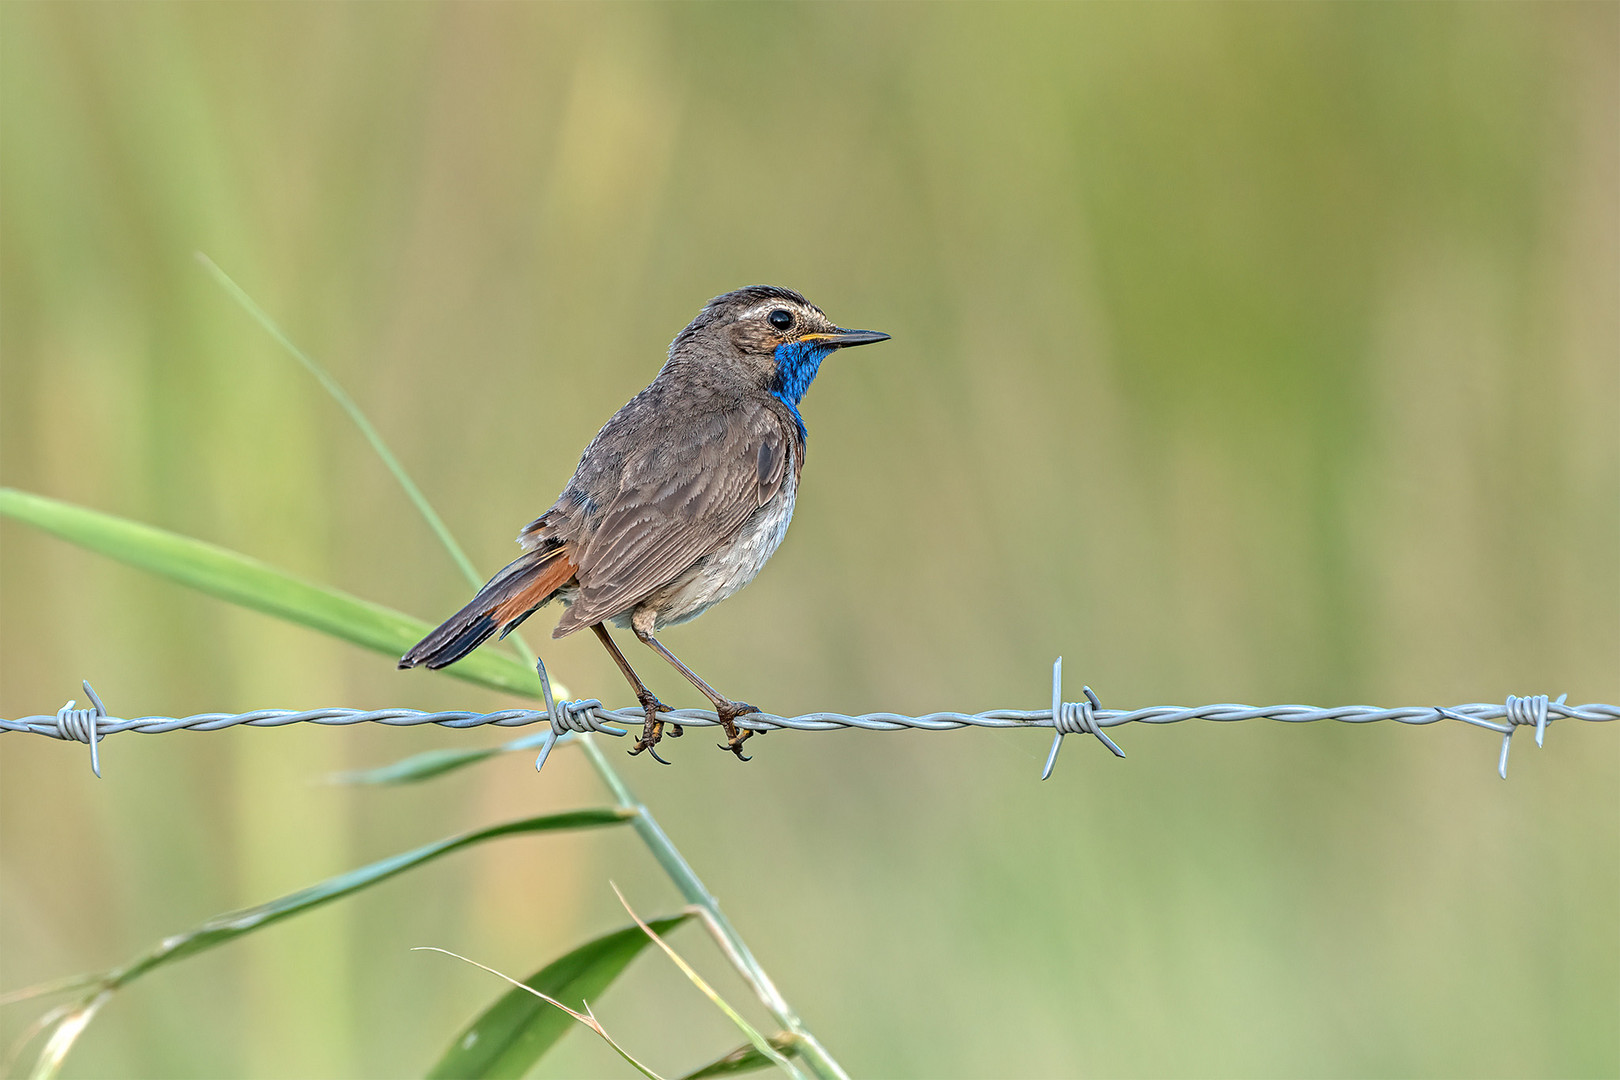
[0,3,1620,1077]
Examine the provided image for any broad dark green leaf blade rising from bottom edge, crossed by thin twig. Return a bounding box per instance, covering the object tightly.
[428,915,692,1080]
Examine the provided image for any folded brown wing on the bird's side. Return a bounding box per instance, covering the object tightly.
[556,401,794,636]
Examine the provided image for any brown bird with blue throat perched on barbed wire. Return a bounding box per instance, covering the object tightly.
[399,285,889,764]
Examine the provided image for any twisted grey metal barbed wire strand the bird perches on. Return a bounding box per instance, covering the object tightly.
[0,656,1620,780]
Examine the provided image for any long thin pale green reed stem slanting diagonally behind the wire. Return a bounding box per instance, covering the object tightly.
[198,259,849,1080]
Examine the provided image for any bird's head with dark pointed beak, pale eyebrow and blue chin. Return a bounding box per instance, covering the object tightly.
[669,285,889,426]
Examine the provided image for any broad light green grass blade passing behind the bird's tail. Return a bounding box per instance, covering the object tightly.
[0,487,539,698]
